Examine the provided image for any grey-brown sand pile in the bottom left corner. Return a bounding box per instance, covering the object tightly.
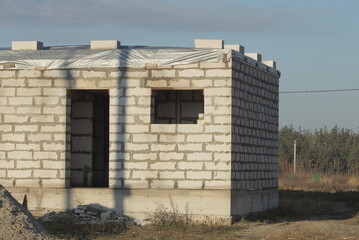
[0,185,55,240]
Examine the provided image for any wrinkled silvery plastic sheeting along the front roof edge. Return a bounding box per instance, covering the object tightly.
[0,46,232,69]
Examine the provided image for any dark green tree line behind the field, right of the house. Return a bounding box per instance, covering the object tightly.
[279,126,359,173]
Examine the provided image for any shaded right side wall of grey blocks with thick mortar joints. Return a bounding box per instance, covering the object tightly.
[232,56,279,190]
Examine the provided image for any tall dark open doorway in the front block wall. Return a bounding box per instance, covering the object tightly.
[69,90,109,187]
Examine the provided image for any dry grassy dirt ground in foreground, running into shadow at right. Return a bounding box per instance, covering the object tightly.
[43,190,359,240]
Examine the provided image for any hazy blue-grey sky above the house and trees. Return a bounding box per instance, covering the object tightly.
[0,0,359,131]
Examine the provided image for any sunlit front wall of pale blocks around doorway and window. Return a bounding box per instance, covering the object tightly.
[0,63,232,192]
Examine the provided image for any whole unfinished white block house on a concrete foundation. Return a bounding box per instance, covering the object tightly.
[0,40,280,220]
